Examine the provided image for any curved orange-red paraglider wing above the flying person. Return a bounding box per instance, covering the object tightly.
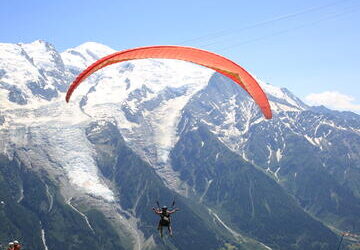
[66,46,272,119]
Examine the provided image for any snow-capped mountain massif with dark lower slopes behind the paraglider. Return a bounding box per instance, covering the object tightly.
[0,41,360,249]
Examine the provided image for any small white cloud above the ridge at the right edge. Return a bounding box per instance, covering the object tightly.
[305,91,360,113]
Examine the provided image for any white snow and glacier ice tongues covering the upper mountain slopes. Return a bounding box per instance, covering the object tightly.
[0,40,360,209]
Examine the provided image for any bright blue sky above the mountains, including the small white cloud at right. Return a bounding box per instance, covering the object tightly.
[0,0,360,112]
